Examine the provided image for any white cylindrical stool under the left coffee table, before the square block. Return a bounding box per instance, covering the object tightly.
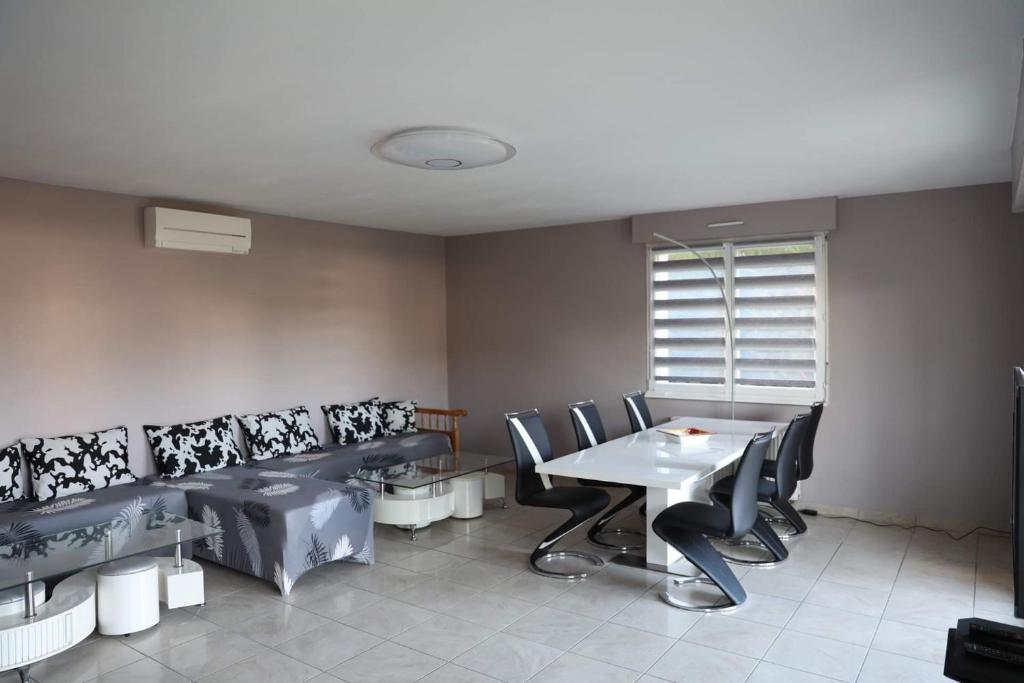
[96,557,160,636]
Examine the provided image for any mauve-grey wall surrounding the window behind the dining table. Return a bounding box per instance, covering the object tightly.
[445,183,1024,527]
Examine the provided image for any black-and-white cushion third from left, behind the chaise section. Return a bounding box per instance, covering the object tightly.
[142,416,245,479]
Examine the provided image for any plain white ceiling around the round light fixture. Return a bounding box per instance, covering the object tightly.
[0,0,1024,234]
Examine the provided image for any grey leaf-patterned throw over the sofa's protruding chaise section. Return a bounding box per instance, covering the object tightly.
[159,466,374,595]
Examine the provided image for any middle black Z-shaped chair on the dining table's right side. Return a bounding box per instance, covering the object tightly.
[711,414,811,567]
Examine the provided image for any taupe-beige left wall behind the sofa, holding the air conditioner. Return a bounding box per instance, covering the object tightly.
[0,179,447,479]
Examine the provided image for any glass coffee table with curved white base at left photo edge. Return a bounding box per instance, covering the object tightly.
[0,510,222,681]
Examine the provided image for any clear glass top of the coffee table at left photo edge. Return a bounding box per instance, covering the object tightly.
[0,511,222,590]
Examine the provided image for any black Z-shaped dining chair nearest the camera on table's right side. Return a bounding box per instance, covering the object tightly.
[651,432,772,612]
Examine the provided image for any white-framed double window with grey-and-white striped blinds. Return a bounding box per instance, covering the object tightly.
[648,236,827,403]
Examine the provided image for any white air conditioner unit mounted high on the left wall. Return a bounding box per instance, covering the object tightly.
[144,207,253,254]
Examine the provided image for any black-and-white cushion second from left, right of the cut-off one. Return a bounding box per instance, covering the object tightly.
[22,427,135,501]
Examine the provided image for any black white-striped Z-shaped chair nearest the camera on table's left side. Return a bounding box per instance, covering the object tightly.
[505,409,611,580]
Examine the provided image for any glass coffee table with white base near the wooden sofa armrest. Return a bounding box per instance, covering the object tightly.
[351,451,513,541]
